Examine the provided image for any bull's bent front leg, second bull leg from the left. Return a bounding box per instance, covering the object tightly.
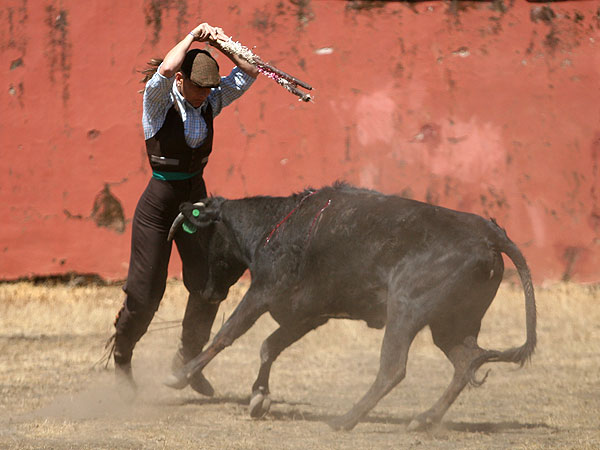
[249,319,327,418]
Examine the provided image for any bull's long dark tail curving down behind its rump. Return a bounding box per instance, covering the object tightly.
[494,223,537,366]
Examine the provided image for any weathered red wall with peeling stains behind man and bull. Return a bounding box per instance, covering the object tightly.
[0,0,600,283]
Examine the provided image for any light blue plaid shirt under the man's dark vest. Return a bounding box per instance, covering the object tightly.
[142,67,254,148]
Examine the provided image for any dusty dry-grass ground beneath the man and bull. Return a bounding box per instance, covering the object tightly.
[0,281,600,449]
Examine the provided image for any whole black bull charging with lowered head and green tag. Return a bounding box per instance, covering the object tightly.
[167,184,536,429]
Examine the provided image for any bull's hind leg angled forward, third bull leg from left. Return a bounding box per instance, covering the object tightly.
[329,300,419,430]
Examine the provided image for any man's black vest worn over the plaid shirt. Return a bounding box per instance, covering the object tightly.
[146,103,213,173]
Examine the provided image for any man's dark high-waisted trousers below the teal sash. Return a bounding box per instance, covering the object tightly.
[115,175,218,364]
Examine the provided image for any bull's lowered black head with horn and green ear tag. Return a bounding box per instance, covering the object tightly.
[169,198,247,302]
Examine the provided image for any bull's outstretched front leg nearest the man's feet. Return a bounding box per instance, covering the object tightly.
[164,286,267,389]
